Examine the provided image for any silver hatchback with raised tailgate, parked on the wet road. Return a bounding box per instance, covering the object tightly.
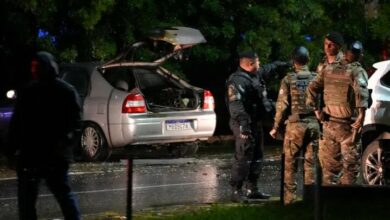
[60,27,216,161]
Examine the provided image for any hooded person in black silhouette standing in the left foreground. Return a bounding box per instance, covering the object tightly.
[7,52,81,220]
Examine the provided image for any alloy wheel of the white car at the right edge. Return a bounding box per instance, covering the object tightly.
[362,140,385,185]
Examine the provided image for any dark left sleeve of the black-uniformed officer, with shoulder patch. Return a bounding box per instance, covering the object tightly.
[227,82,251,127]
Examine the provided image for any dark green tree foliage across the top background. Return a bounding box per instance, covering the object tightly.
[0,0,390,84]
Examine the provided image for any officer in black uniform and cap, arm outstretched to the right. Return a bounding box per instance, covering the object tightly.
[226,51,288,202]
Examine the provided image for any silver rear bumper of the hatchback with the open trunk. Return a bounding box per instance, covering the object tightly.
[109,112,216,147]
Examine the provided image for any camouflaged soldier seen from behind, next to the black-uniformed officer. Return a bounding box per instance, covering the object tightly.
[270,46,320,205]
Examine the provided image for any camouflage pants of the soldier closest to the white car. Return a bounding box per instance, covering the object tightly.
[318,121,360,185]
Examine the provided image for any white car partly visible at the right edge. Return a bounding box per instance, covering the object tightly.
[362,60,390,185]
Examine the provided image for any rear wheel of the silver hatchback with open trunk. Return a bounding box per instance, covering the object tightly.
[81,123,109,161]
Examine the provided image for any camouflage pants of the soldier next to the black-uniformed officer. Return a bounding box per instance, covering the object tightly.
[283,118,320,204]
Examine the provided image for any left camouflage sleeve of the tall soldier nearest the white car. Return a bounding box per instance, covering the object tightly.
[306,71,324,109]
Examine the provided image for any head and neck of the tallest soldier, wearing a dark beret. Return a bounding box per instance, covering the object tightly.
[316,31,344,73]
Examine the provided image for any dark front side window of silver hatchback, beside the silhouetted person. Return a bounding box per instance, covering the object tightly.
[61,67,89,98]
